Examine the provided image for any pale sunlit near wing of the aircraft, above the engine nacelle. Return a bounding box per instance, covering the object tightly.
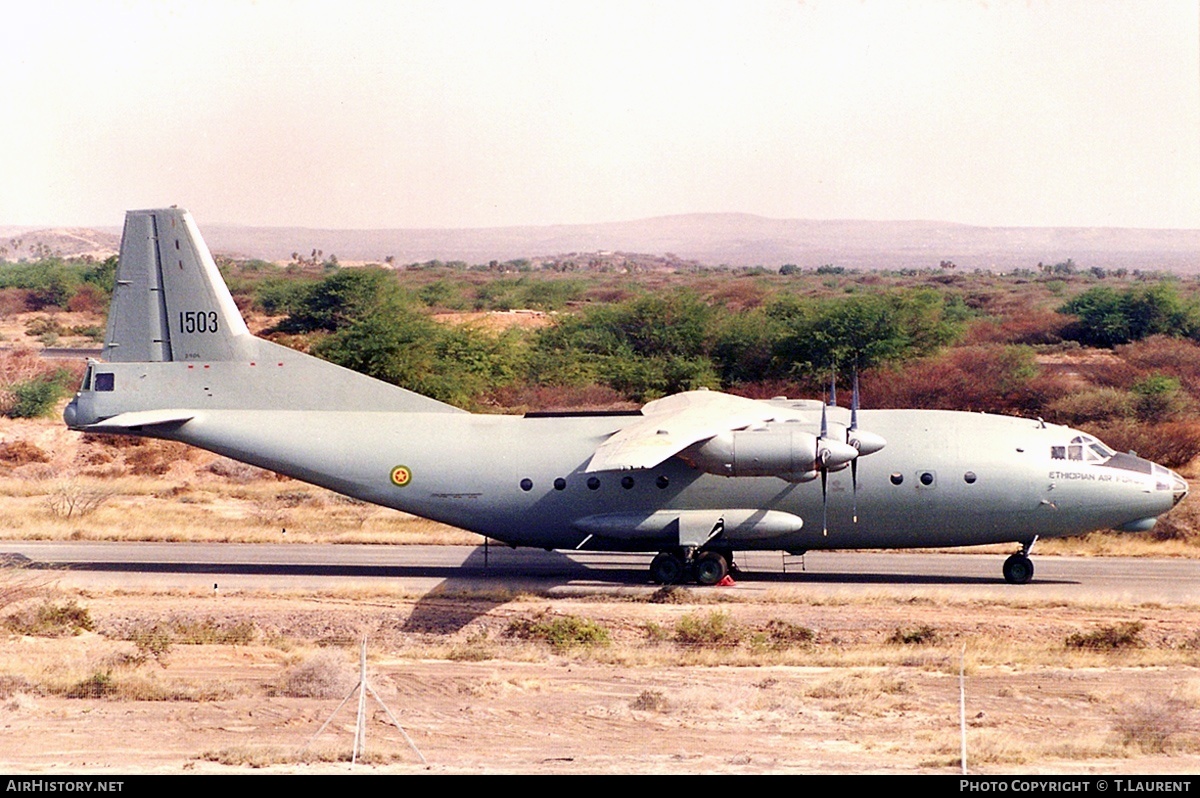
[584,391,799,472]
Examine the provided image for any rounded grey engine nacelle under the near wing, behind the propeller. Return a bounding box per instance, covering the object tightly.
[679,425,858,482]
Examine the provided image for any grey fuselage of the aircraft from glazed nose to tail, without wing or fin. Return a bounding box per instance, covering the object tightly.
[68,357,1182,551]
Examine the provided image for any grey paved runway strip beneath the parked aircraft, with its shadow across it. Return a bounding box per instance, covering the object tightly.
[0,541,1200,605]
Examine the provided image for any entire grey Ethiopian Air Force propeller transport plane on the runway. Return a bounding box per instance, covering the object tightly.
[65,208,1188,584]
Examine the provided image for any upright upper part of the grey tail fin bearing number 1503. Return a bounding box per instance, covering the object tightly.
[102,208,253,362]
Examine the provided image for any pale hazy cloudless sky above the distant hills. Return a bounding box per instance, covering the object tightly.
[0,0,1200,228]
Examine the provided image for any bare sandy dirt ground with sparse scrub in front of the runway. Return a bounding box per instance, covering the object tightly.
[0,589,1200,775]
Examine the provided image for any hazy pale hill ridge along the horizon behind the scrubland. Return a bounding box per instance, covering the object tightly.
[0,214,1200,274]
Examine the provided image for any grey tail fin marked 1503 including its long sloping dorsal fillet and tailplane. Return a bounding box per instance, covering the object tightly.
[65,208,462,432]
